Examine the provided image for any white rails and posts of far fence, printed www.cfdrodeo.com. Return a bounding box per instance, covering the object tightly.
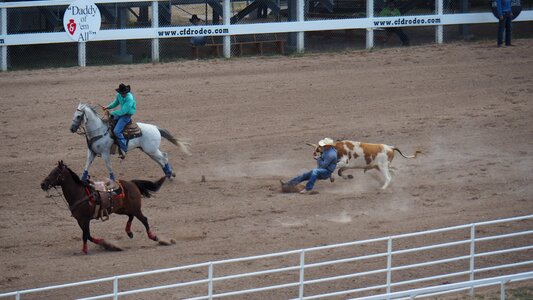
[0,0,533,71]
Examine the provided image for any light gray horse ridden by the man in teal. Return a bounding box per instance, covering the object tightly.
[70,103,190,181]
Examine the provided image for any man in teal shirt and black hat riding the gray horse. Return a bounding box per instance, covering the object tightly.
[105,83,137,159]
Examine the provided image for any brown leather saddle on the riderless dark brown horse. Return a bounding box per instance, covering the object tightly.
[89,179,125,222]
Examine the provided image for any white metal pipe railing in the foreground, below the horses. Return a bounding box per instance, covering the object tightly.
[0,215,533,300]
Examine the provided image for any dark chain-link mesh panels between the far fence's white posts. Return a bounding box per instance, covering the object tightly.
[1,0,533,70]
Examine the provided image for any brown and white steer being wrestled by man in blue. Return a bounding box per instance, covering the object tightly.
[308,140,422,189]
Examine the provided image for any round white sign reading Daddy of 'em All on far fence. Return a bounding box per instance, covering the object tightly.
[63,0,102,42]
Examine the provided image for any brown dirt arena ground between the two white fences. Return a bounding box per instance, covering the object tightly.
[0,40,533,299]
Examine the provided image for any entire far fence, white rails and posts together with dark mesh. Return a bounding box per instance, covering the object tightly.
[0,0,533,71]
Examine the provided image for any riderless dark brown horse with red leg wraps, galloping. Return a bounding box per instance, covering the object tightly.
[41,161,166,254]
